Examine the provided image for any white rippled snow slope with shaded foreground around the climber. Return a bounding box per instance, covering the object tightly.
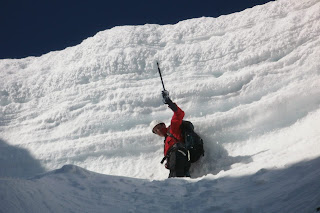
[0,0,320,213]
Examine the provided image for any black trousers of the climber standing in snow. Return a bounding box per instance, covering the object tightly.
[167,148,191,178]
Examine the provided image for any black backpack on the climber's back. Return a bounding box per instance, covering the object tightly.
[180,120,204,163]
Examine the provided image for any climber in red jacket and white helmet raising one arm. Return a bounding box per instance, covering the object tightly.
[150,91,190,178]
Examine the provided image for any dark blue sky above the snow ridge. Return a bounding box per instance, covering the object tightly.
[0,0,270,59]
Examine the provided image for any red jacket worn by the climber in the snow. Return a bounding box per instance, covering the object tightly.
[164,106,184,156]
